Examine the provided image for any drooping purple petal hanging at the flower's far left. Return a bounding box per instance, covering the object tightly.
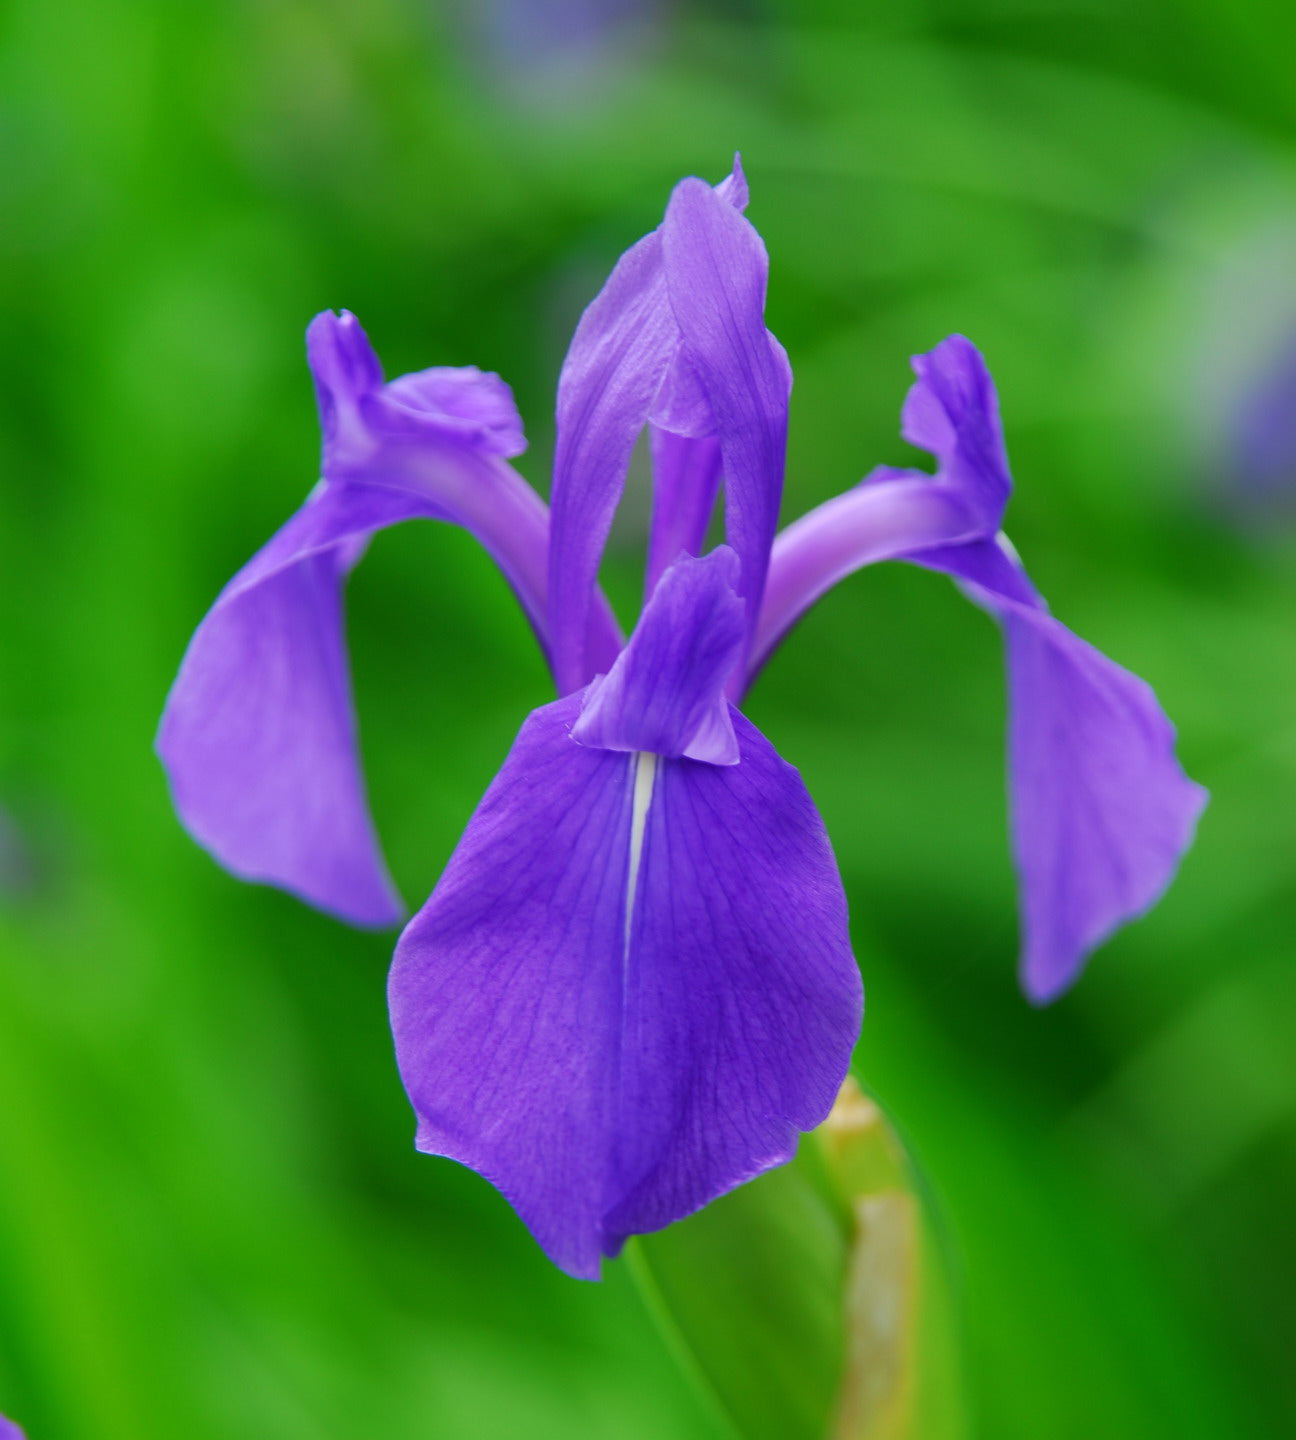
[157,485,428,926]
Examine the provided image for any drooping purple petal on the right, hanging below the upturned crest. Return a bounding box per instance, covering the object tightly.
[910,540,1207,1004]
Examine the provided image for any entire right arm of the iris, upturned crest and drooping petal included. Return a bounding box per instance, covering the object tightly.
[749,336,1205,1002]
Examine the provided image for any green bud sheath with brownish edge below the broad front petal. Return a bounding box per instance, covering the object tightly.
[629,1079,966,1440]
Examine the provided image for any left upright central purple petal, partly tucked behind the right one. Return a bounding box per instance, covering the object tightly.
[549,157,747,694]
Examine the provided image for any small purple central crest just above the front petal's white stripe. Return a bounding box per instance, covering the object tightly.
[572,546,744,765]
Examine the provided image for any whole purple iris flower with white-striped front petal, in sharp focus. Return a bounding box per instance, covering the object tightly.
[158,166,1204,1277]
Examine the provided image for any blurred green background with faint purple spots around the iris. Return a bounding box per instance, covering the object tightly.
[0,0,1296,1440]
